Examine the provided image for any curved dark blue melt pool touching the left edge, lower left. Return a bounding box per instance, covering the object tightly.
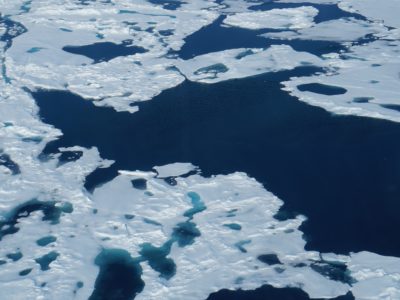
[0,199,73,241]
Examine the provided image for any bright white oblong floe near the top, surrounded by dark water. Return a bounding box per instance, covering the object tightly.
[224,6,318,29]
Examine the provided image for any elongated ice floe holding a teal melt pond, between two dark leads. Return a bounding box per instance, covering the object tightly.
[176,45,324,83]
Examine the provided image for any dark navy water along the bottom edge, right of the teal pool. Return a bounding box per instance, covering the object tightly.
[207,285,355,300]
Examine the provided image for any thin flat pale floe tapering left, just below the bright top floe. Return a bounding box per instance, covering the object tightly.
[262,18,386,42]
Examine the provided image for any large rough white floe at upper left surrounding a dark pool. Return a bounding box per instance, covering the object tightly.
[1,0,218,112]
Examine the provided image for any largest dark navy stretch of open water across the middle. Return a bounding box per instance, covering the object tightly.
[33,68,400,256]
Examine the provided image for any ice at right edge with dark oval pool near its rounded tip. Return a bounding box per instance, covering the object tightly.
[284,40,400,122]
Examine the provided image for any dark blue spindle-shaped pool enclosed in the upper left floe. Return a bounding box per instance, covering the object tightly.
[62,40,148,63]
